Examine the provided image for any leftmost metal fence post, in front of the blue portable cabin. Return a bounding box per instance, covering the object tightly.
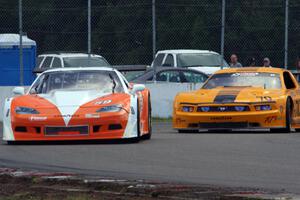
[19,0,24,86]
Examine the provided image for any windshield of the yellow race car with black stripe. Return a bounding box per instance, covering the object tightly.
[202,72,281,89]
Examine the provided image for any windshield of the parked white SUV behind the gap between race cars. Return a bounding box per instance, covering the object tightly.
[177,53,227,67]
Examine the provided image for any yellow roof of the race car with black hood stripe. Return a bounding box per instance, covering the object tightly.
[215,67,285,74]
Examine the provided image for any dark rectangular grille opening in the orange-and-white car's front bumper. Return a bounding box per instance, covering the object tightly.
[45,126,89,136]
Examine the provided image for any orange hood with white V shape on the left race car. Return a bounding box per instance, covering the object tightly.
[11,91,130,125]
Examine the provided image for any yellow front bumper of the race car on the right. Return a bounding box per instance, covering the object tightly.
[173,110,285,130]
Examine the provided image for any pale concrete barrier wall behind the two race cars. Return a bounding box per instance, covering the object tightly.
[0,83,202,121]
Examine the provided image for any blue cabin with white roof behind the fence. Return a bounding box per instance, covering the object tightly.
[0,34,36,86]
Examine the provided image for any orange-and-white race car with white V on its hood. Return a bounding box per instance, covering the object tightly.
[3,68,151,143]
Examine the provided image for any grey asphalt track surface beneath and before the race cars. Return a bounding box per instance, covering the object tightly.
[0,122,300,194]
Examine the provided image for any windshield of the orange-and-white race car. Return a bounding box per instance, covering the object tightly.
[30,71,124,94]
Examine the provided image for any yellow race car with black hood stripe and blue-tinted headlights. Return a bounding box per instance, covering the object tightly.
[173,67,300,132]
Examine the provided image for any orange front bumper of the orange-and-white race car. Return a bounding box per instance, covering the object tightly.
[4,110,136,141]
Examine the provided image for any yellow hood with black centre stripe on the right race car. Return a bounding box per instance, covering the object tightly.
[177,87,283,104]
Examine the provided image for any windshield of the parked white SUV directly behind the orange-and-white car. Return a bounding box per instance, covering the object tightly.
[63,57,110,67]
